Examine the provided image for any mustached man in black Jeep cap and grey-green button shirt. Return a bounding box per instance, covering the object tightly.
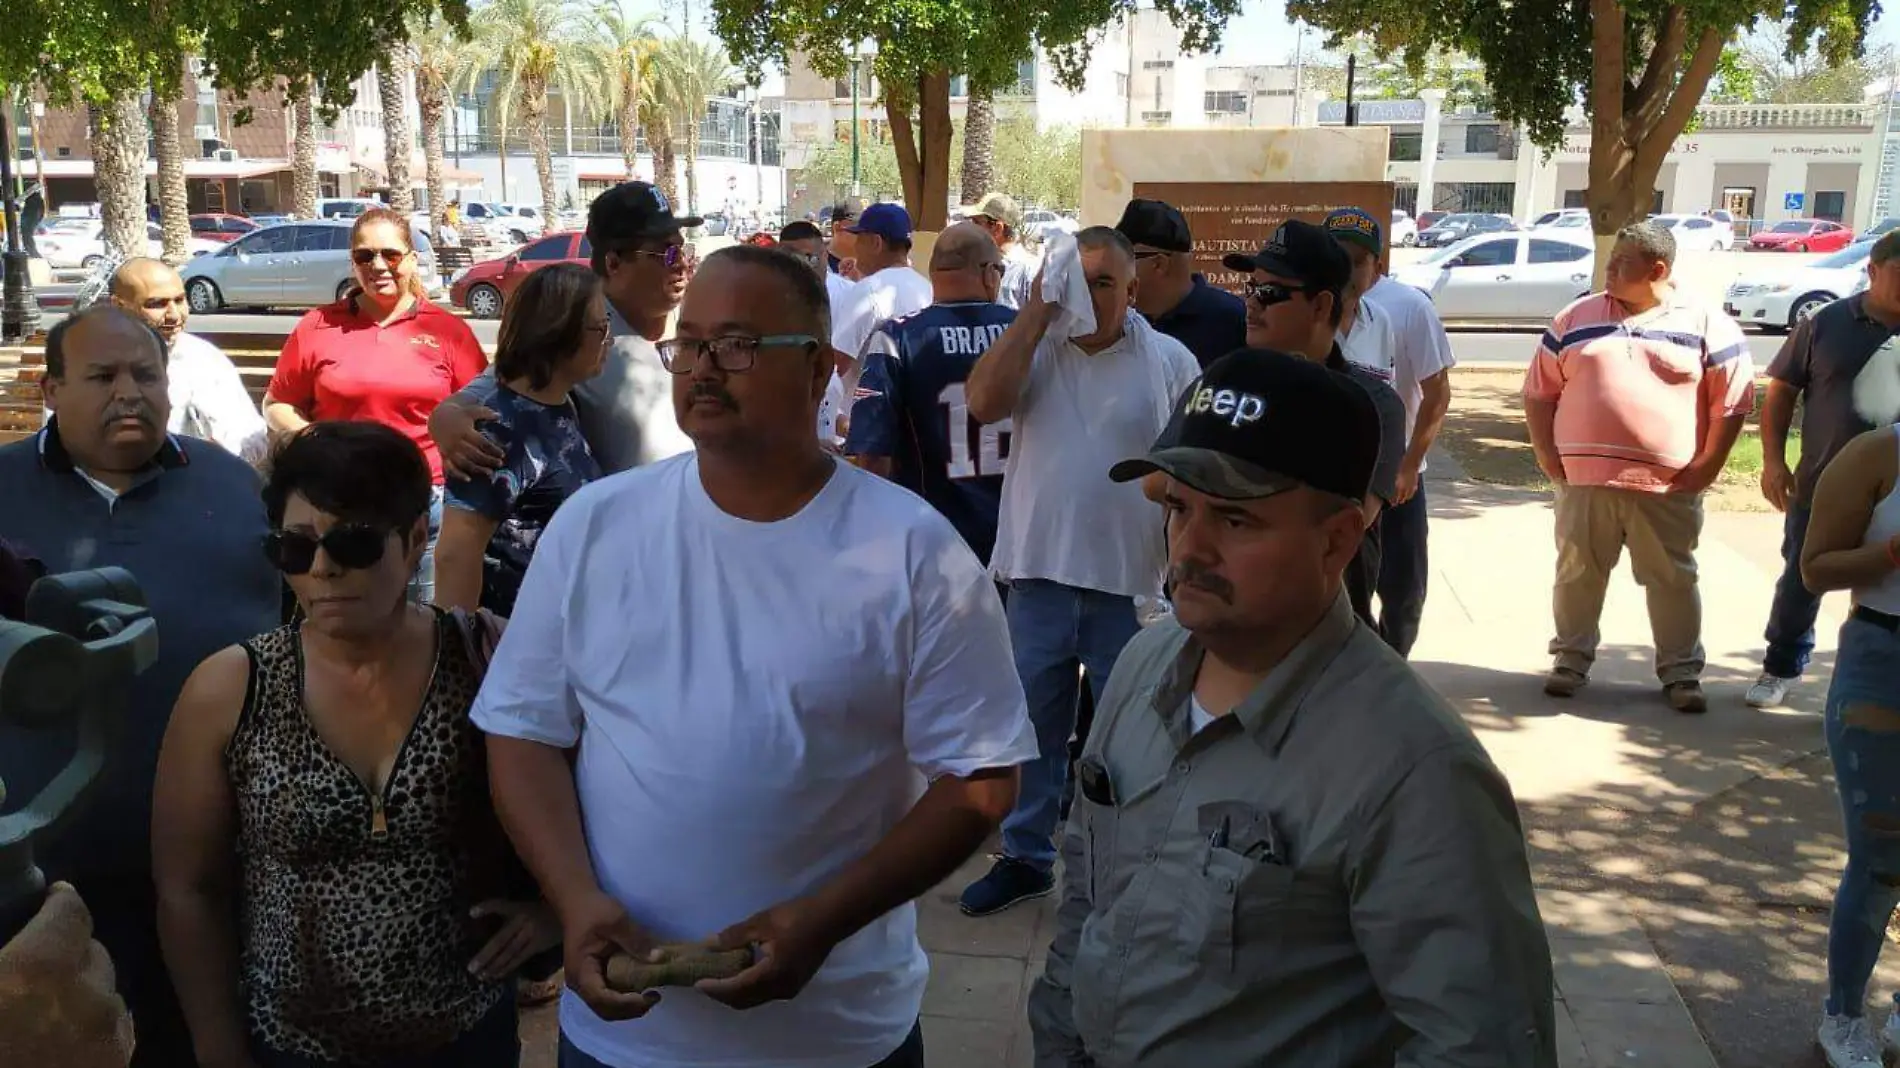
[1030,350,1556,1068]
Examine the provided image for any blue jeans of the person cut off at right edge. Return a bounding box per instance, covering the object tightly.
[1826,620,1900,1017]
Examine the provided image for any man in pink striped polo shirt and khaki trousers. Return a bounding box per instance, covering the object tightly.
[1524,224,1756,713]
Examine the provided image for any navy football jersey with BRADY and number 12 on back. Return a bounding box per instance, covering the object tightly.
[844,300,1017,564]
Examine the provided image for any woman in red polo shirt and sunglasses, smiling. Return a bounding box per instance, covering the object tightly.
[264,207,488,602]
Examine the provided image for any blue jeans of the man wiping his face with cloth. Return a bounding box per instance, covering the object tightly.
[1003,580,1140,870]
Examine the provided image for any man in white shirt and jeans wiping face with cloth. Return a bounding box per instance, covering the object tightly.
[960,226,1199,916]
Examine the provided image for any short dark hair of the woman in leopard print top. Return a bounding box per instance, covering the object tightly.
[264,422,435,540]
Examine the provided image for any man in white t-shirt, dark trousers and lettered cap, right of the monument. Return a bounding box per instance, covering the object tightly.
[1326,207,1457,656]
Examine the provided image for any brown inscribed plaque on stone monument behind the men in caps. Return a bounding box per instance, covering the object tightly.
[1134,182,1393,293]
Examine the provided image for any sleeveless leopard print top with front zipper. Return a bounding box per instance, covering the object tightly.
[224,612,511,1060]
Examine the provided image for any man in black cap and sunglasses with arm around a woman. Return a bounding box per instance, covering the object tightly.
[429,182,703,479]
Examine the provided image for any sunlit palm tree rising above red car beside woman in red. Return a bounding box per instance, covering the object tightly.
[464,0,604,215]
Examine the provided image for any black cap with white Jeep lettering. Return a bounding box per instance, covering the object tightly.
[1108,347,1379,500]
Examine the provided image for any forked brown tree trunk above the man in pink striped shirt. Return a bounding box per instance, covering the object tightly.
[1585,0,1725,289]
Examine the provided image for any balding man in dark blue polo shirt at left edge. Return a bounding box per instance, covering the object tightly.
[0,304,283,1068]
